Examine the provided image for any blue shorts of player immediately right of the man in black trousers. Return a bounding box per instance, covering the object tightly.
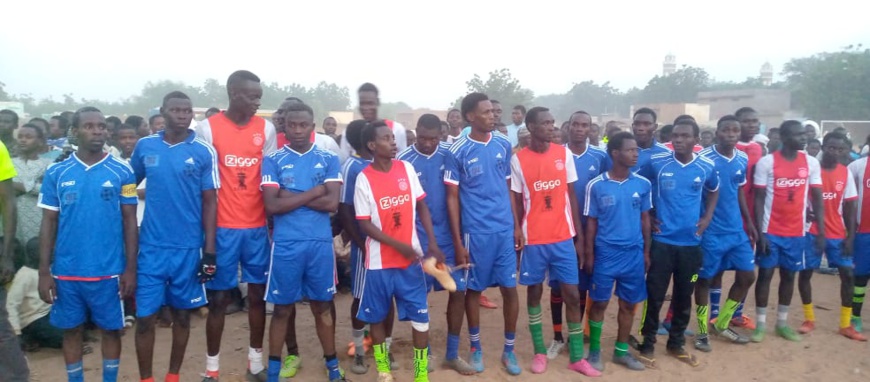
[698,232,755,280]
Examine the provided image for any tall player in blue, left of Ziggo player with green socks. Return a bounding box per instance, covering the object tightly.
[444,93,523,375]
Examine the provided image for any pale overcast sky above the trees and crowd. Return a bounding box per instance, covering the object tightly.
[0,0,870,108]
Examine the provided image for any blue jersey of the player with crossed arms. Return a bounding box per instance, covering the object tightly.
[260,145,341,242]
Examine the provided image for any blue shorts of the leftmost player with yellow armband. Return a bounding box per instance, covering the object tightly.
[49,277,124,330]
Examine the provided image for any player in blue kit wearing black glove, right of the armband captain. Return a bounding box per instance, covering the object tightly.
[134,91,220,382]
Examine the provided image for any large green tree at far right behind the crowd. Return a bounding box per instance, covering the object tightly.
[783,45,870,120]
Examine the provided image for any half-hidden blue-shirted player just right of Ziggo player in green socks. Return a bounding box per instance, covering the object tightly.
[547,111,611,359]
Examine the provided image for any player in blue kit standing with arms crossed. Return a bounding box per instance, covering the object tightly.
[261,103,344,382]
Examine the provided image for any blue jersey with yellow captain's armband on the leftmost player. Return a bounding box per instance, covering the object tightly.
[38,154,139,277]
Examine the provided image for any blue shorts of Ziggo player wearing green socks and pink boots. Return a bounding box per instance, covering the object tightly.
[520,239,580,285]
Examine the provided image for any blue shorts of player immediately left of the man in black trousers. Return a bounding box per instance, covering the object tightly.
[589,245,646,304]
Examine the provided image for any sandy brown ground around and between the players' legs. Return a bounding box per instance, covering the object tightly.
[28,274,870,382]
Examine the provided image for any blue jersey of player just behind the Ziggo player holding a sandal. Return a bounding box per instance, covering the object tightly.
[398,143,452,244]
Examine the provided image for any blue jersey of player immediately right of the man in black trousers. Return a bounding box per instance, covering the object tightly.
[698,146,749,234]
